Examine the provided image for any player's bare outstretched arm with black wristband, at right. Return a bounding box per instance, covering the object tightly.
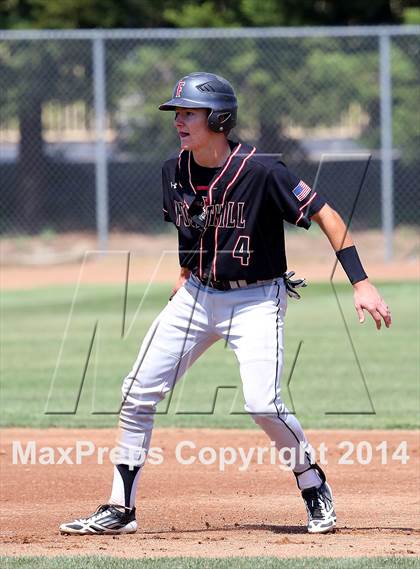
[311,204,391,330]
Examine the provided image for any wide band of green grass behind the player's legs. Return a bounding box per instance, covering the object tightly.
[1,283,419,429]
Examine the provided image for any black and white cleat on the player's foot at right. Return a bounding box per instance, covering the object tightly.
[302,480,337,533]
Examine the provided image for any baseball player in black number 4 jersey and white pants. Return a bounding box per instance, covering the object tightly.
[60,73,391,534]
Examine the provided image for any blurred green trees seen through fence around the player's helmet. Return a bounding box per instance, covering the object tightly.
[108,32,420,161]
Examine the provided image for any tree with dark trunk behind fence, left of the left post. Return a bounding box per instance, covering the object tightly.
[0,40,92,231]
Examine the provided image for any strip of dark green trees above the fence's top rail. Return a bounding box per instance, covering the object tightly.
[0,0,420,29]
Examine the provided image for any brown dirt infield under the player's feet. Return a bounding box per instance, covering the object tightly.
[0,429,420,557]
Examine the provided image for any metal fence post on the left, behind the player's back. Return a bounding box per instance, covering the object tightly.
[92,36,109,251]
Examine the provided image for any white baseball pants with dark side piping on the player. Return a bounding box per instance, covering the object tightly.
[118,276,316,474]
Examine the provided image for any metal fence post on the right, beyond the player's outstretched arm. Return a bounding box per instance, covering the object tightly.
[379,33,394,261]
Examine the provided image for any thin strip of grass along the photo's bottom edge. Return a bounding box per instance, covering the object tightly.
[0,557,419,569]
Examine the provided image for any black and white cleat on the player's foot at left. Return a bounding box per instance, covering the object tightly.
[60,504,137,535]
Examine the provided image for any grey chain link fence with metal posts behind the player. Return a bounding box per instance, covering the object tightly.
[0,26,420,258]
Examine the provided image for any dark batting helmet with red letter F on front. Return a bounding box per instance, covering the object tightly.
[159,72,238,132]
